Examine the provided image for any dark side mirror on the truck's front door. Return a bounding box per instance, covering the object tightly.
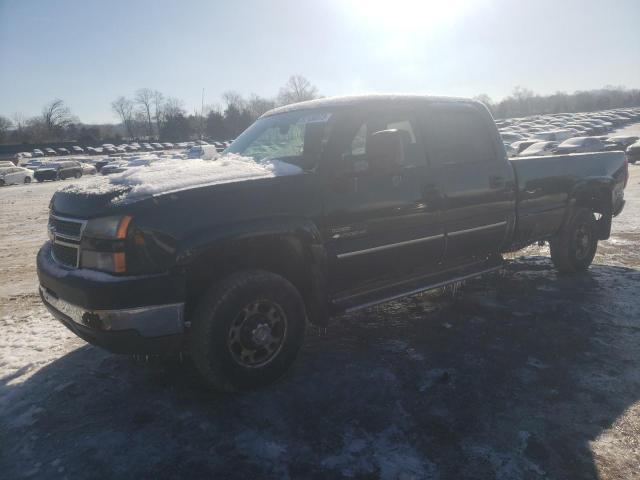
[367,128,411,175]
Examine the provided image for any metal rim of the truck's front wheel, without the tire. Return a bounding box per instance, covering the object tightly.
[227,299,287,368]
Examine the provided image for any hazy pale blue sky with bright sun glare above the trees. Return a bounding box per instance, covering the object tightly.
[0,0,640,123]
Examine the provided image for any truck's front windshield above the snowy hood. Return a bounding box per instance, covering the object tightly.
[224,110,332,168]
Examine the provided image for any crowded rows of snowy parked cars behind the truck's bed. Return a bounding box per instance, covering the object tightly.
[496,108,640,163]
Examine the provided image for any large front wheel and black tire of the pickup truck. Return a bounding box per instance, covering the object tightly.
[190,270,307,392]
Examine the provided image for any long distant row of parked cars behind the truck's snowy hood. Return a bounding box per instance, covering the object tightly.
[15,140,231,160]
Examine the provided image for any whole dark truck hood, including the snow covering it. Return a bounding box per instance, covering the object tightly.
[51,155,302,218]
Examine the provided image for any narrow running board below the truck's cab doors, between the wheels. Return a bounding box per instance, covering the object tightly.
[333,258,505,313]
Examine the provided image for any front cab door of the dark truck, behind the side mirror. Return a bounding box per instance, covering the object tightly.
[323,109,444,292]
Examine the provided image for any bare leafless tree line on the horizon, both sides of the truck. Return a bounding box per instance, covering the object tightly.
[0,81,640,145]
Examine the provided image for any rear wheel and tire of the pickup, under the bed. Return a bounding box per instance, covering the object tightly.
[549,208,598,273]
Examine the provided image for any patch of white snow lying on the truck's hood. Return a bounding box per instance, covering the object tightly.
[60,154,302,203]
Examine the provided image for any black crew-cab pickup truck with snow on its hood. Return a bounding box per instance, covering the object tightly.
[37,95,628,390]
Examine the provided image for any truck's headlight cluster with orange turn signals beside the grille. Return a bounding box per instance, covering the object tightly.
[80,215,132,273]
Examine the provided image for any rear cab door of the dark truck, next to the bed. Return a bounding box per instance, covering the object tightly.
[422,102,515,264]
